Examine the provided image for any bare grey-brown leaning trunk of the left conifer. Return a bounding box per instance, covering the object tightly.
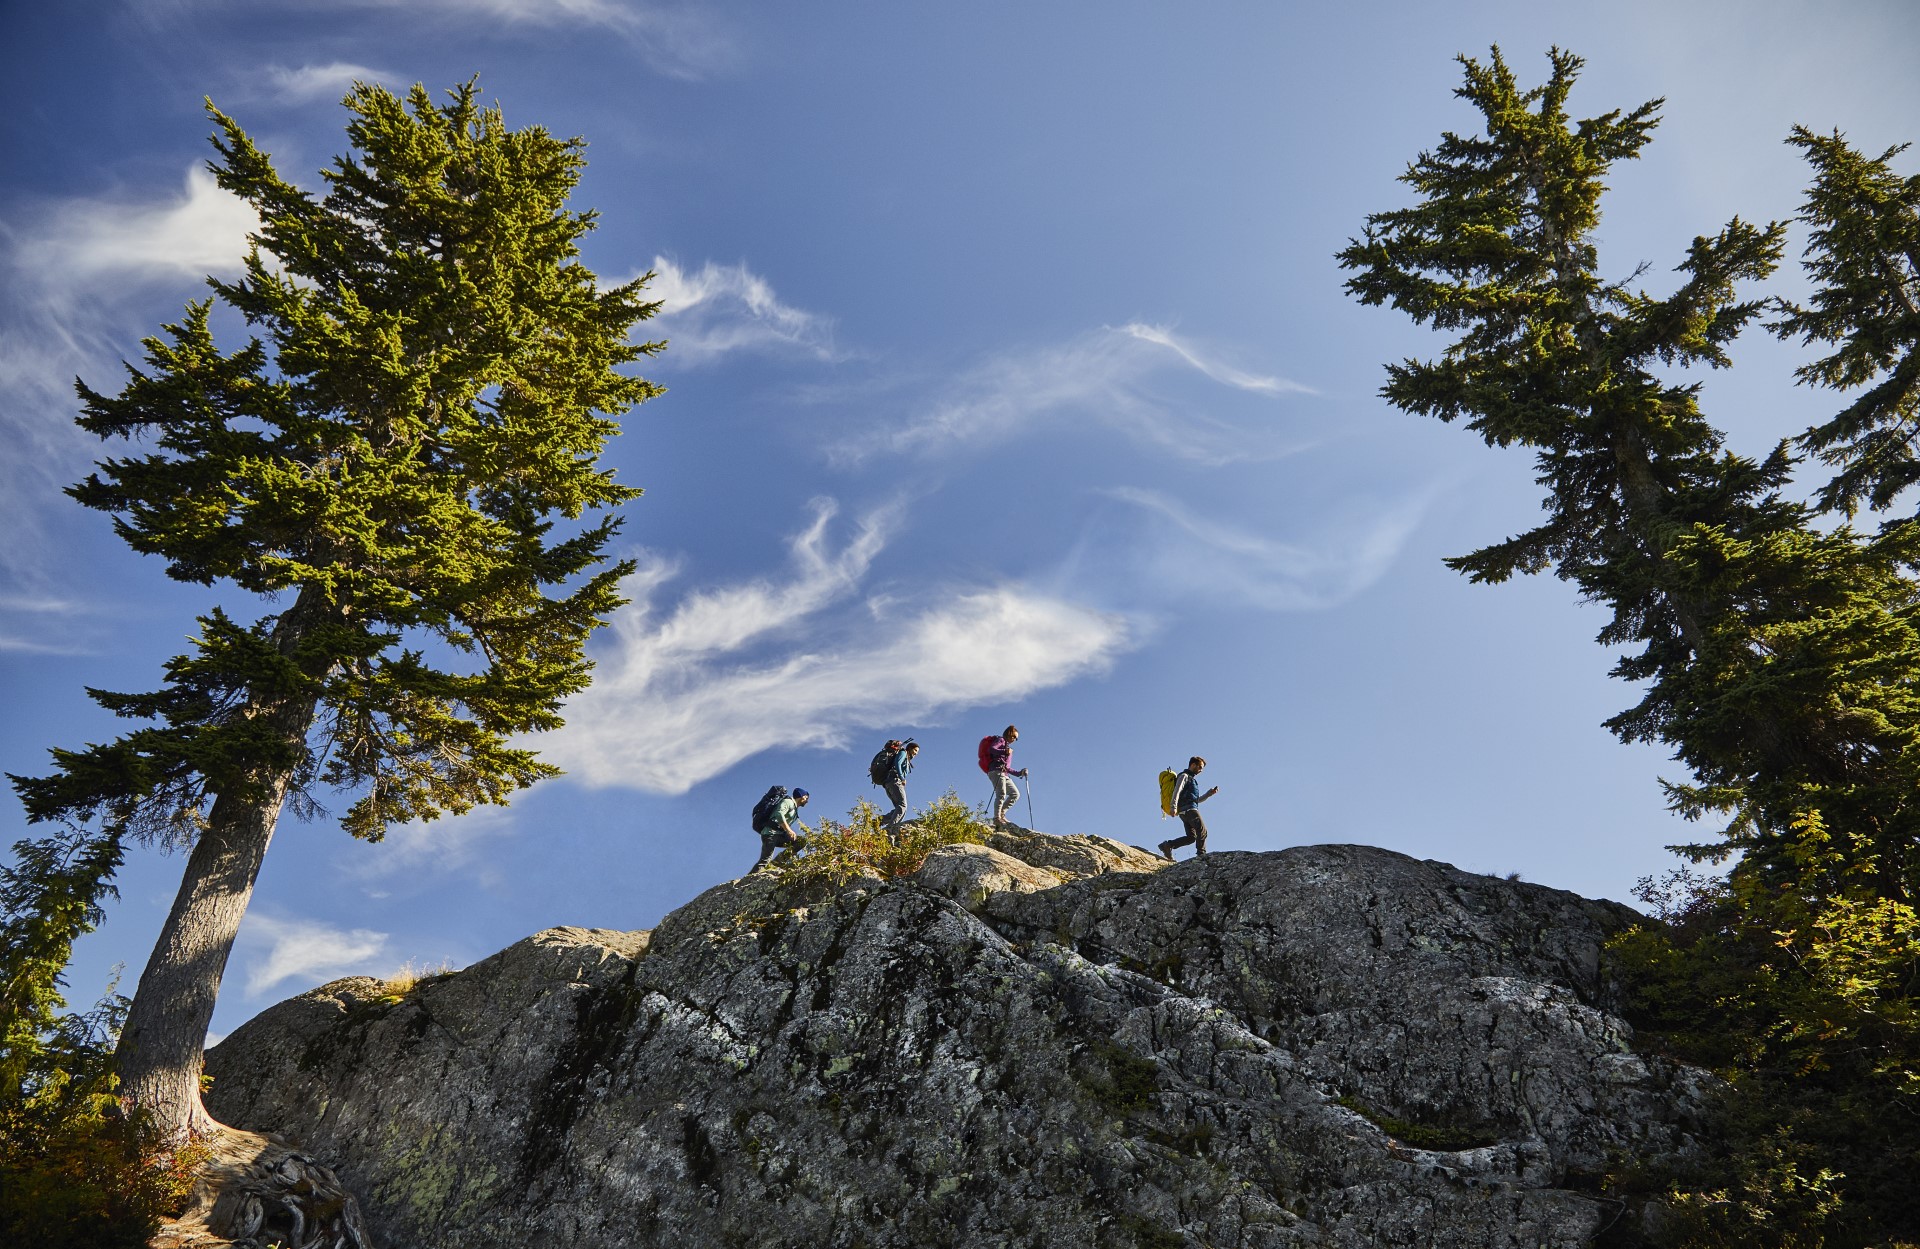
[115,775,288,1143]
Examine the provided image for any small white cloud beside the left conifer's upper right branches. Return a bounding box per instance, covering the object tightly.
[643,255,839,365]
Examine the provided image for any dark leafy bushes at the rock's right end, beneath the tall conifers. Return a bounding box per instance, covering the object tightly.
[1607,836,1920,1249]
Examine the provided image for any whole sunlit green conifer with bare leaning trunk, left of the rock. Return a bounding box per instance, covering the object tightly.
[13,82,660,1140]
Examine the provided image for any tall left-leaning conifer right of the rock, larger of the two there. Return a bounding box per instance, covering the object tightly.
[1340,50,1920,896]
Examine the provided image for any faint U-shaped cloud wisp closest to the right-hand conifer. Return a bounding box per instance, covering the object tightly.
[1098,485,1432,612]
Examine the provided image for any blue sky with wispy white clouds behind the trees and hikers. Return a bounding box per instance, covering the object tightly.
[0,0,1920,1032]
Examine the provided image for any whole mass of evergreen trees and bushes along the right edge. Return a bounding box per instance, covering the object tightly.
[1340,48,1920,1247]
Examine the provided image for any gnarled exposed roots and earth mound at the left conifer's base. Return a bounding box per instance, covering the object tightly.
[150,1126,372,1249]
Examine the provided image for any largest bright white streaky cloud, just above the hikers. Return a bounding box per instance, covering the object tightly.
[540,501,1131,794]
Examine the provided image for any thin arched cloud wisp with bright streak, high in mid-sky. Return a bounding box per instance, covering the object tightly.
[835,322,1315,466]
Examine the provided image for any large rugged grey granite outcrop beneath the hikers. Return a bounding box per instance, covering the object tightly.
[207,835,1707,1249]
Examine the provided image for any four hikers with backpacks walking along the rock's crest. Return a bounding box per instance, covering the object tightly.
[753,725,1219,871]
